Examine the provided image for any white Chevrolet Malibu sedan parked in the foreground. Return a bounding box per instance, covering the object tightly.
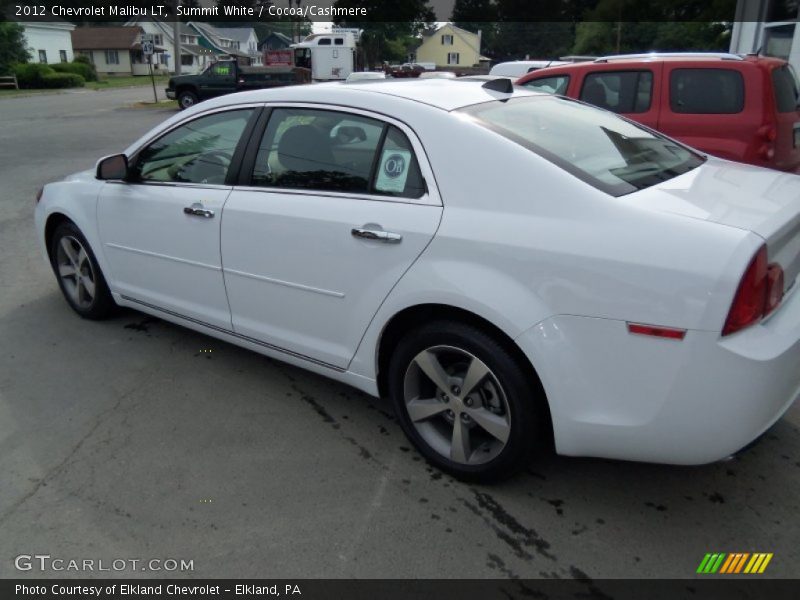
[36,80,800,478]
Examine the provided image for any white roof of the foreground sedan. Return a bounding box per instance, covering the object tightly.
[198,79,546,111]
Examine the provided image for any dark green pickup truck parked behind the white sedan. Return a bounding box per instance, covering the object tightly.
[166,60,311,109]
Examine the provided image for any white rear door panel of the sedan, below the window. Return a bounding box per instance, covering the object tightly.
[222,189,442,369]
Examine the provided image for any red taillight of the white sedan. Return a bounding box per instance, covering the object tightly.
[722,246,783,335]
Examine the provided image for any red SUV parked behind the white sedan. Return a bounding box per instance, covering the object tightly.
[517,53,800,172]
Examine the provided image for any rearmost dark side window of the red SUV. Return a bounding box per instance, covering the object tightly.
[669,69,744,115]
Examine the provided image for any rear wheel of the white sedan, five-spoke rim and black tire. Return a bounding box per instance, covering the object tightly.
[389,321,547,480]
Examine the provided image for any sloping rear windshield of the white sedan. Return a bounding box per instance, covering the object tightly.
[460,96,705,196]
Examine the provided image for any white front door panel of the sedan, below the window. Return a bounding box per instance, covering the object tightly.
[97,182,231,329]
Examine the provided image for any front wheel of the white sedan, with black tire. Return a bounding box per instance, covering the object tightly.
[50,221,117,320]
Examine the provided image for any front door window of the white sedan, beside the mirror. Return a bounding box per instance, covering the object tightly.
[135,109,253,185]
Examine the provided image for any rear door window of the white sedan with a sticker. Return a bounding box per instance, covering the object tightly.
[251,108,424,198]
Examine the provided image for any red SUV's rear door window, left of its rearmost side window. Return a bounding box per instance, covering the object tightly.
[580,71,653,114]
